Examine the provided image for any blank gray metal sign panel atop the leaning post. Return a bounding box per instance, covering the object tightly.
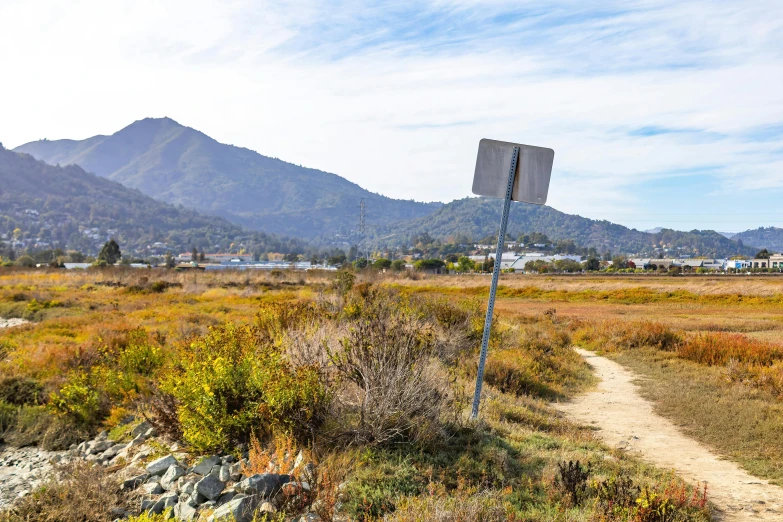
[473,139,555,205]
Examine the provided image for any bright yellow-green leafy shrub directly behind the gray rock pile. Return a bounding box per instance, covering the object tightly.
[162,323,327,451]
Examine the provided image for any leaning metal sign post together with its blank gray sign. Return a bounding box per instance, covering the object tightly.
[470,139,555,419]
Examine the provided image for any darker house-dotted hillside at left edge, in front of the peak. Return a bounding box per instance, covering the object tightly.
[0,146,303,255]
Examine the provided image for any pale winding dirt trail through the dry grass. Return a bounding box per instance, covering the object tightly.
[557,348,783,522]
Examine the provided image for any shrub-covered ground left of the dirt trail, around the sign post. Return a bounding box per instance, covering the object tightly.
[0,270,709,522]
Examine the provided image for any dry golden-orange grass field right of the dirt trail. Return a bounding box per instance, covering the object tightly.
[395,275,783,484]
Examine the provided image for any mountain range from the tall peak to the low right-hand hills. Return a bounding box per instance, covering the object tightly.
[7,118,783,257]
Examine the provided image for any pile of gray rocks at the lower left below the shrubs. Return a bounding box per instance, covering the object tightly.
[0,422,320,522]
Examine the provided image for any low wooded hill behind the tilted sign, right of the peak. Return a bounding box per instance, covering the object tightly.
[375,197,755,257]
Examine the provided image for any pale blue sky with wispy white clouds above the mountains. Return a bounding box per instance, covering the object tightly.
[0,0,783,232]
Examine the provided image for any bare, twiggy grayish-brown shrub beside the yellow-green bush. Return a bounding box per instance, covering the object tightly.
[328,287,449,444]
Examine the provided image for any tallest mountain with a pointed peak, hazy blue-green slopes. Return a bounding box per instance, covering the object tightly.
[15,118,441,238]
